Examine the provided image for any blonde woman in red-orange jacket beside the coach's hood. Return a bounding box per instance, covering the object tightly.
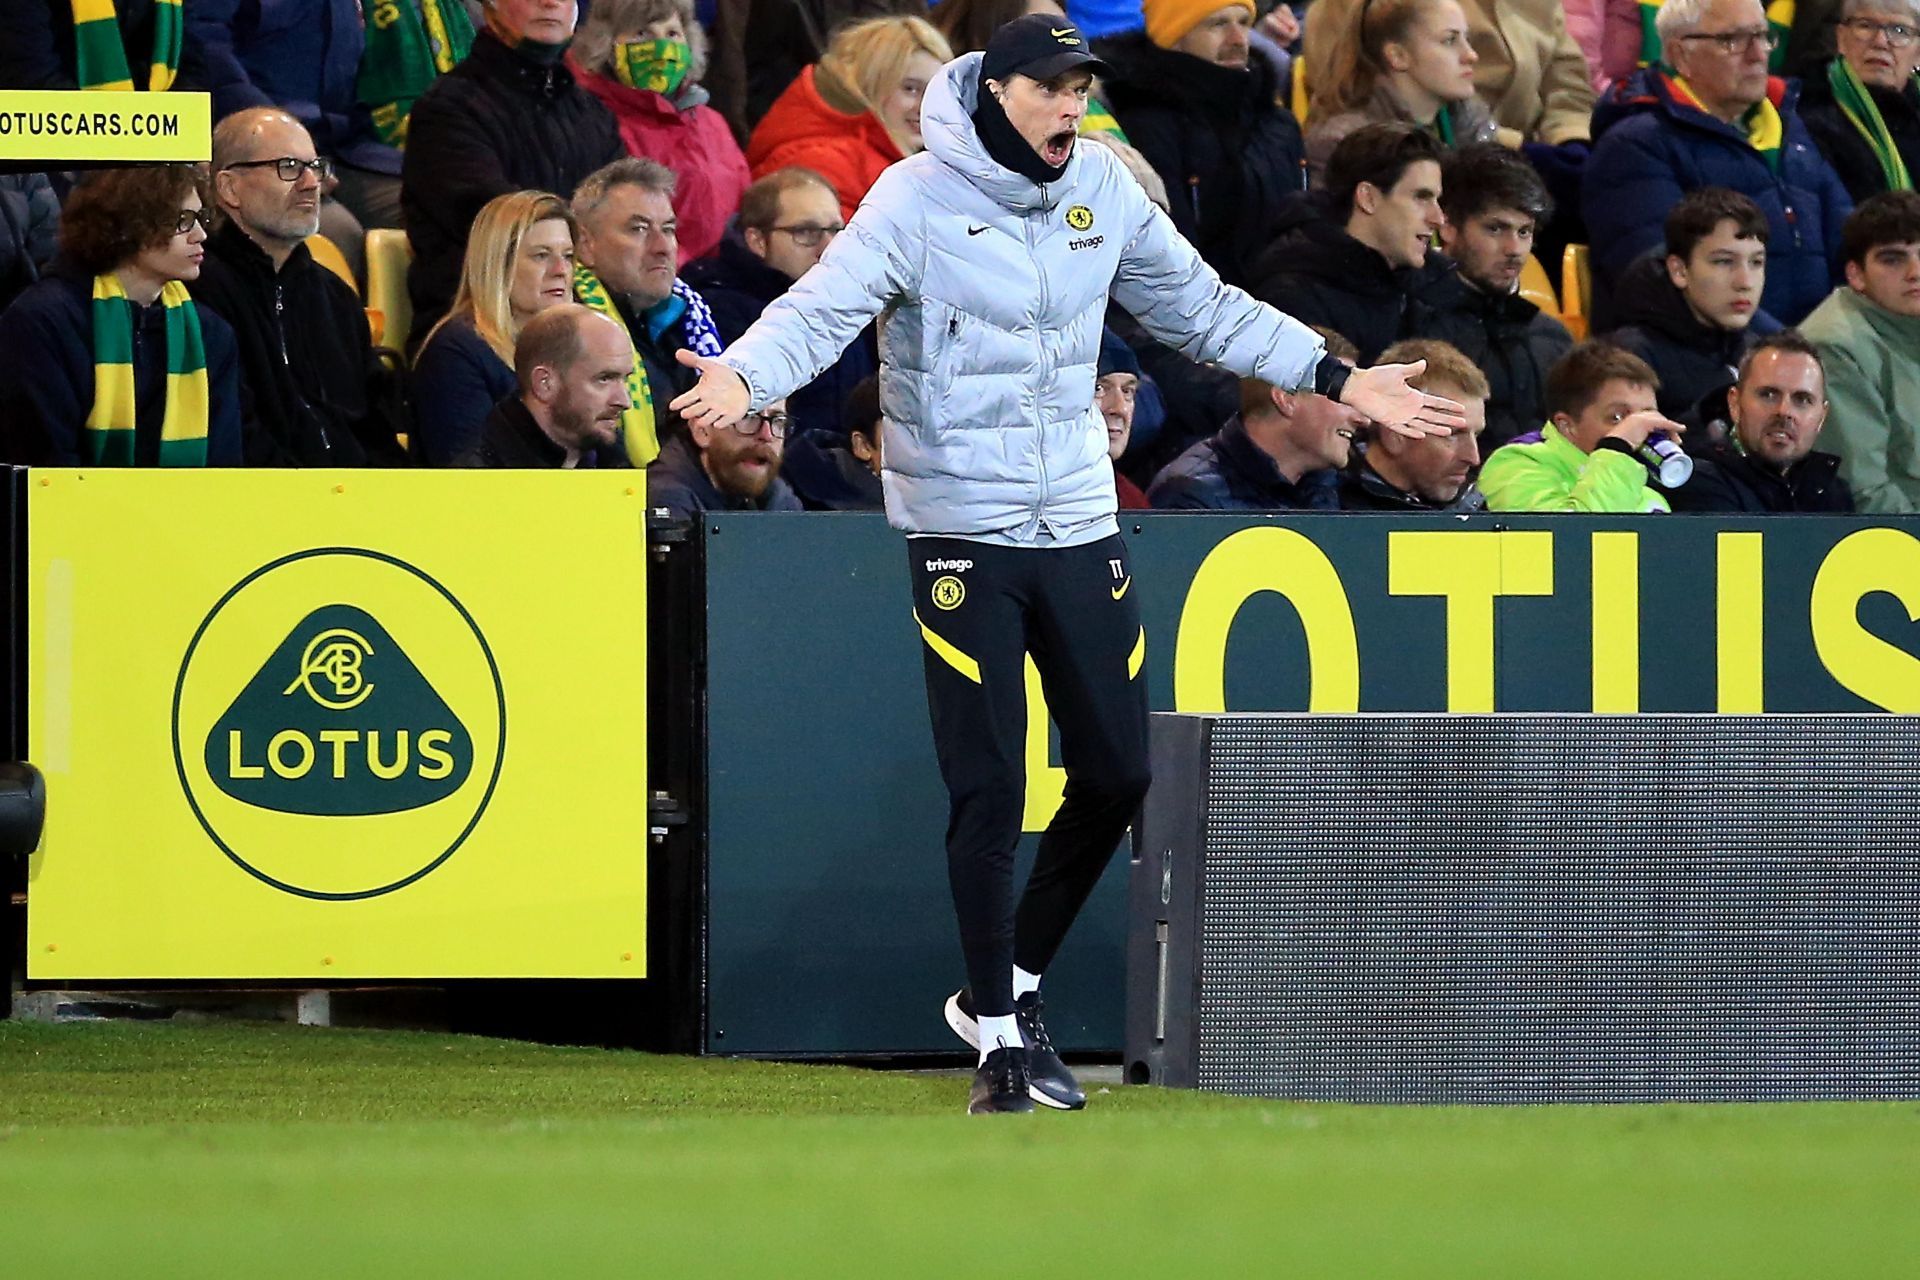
[747,17,952,219]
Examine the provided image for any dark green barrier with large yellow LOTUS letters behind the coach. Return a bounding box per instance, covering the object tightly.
[705,516,1920,1054]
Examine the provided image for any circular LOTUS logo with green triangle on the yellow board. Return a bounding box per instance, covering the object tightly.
[173,547,507,900]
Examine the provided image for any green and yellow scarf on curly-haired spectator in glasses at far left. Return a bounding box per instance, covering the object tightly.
[81,273,207,466]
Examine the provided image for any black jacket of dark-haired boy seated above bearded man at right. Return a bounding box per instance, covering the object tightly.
[1607,251,1780,424]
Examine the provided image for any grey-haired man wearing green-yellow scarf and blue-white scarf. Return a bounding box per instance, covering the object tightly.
[574,155,720,466]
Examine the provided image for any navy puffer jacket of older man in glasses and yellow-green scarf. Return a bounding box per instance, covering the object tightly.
[1580,69,1853,324]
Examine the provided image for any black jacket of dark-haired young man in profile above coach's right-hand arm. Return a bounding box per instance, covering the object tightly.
[1248,192,1446,365]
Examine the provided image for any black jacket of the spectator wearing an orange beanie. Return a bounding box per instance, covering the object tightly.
[1096,33,1308,284]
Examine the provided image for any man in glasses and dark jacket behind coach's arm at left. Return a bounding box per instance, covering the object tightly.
[685,169,879,443]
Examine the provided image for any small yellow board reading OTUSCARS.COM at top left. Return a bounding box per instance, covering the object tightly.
[0,88,213,167]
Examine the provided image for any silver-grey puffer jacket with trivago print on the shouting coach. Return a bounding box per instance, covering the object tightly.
[722,54,1325,541]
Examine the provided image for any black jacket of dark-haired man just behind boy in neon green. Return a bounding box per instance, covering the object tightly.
[1419,271,1572,451]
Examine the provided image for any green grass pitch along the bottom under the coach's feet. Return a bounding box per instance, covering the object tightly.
[0,1023,1920,1280]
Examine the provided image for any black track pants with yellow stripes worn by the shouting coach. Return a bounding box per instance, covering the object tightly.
[906,533,1148,1017]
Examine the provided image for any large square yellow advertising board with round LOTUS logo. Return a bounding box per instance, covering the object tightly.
[27,470,649,981]
